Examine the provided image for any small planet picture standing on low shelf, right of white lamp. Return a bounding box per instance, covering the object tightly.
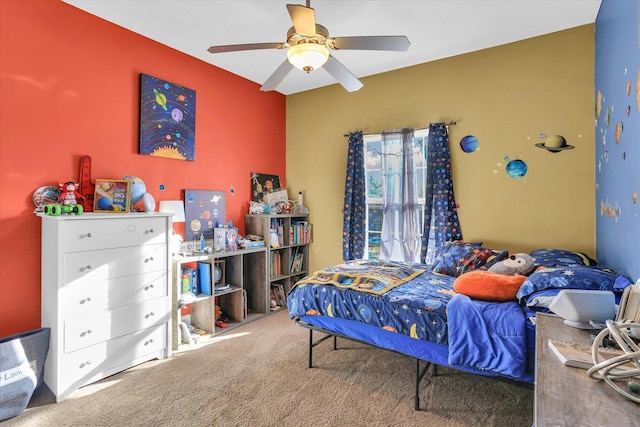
[184,190,225,241]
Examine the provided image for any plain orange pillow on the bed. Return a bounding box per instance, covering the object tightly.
[453,270,527,302]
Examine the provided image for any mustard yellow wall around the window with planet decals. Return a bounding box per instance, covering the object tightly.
[286,25,595,270]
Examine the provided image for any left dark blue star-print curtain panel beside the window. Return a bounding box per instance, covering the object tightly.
[342,131,366,261]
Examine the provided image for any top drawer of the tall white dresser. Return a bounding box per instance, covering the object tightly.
[61,217,167,253]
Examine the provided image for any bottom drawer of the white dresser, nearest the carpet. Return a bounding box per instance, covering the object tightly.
[59,323,167,396]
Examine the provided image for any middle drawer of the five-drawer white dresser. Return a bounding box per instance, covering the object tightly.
[59,270,167,318]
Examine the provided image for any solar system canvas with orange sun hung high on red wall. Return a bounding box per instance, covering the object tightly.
[139,74,196,161]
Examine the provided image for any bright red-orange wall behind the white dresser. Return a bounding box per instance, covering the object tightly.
[0,0,286,337]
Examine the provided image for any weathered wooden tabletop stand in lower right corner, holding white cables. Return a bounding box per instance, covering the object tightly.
[535,313,640,427]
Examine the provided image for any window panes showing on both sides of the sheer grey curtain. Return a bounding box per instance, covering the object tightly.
[364,129,435,259]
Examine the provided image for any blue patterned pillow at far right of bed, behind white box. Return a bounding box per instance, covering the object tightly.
[516,264,618,302]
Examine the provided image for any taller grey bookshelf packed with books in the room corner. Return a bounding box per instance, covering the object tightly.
[245,214,312,311]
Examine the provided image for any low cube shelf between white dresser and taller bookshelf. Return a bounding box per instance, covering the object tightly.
[172,247,269,351]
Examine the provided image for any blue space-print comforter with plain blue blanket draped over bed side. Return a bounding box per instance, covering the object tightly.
[287,260,526,379]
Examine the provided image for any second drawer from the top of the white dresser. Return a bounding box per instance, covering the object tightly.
[60,244,167,286]
